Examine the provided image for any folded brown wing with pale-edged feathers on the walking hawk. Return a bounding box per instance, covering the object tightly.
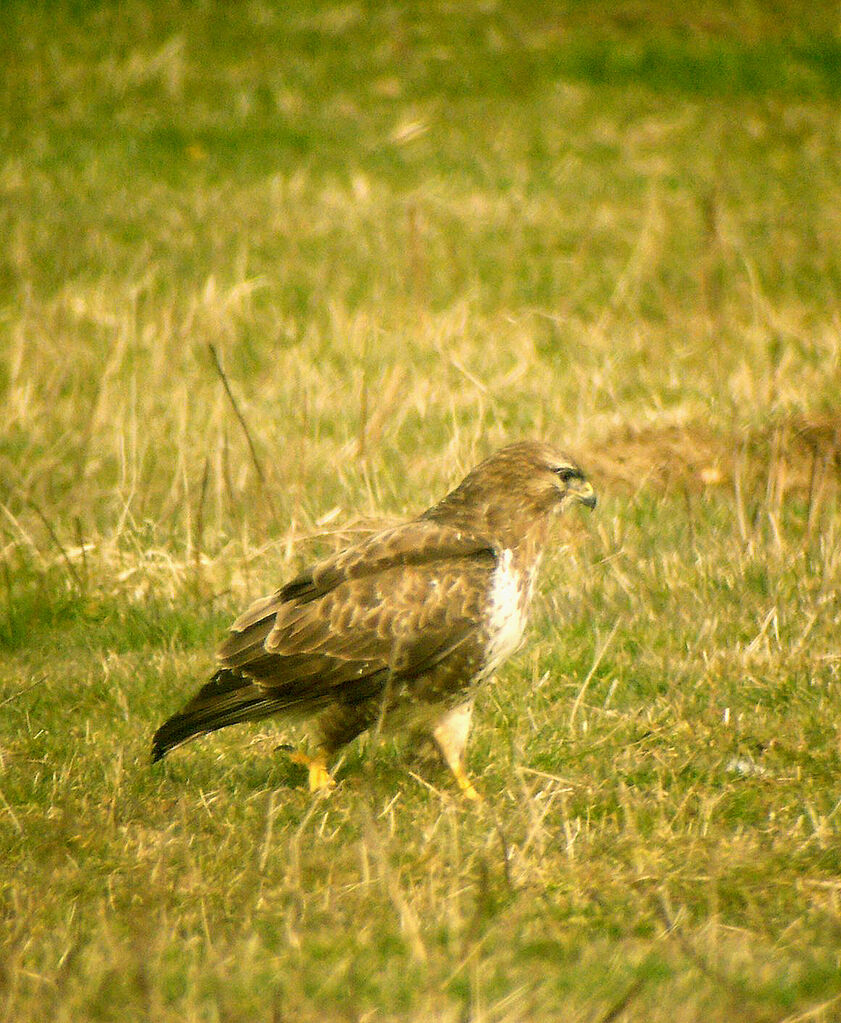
[218,522,496,706]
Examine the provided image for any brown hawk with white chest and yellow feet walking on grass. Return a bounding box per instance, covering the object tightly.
[152,441,595,799]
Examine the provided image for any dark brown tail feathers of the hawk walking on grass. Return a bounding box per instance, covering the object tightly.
[151,668,285,763]
